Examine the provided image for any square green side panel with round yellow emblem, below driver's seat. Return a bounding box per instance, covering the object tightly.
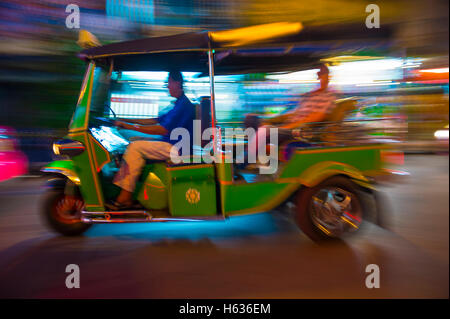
[167,165,217,216]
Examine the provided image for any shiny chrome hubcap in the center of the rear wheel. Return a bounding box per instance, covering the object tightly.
[310,187,362,237]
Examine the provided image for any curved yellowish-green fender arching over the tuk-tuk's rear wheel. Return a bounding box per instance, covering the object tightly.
[299,161,369,187]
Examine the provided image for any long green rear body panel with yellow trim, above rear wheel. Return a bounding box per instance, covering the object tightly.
[217,145,383,215]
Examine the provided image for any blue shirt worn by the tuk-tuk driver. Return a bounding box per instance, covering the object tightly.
[158,93,195,148]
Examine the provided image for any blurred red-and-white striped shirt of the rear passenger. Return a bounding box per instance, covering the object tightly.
[287,89,336,123]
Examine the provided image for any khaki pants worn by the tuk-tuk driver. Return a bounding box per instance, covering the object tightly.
[114,141,174,192]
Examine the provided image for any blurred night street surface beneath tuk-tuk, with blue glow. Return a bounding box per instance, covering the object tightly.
[0,155,449,298]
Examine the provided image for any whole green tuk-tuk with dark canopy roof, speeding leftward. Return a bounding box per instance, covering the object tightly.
[42,23,402,241]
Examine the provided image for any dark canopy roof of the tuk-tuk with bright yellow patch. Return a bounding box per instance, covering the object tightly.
[79,23,391,74]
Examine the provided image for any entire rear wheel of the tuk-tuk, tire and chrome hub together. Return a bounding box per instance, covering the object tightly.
[296,176,364,242]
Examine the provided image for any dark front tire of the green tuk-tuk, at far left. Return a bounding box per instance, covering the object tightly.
[41,188,91,236]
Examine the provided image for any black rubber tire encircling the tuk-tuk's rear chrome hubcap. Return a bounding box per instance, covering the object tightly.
[295,176,367,243]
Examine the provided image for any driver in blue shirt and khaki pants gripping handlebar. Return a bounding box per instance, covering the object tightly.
[106,71,195,210]
